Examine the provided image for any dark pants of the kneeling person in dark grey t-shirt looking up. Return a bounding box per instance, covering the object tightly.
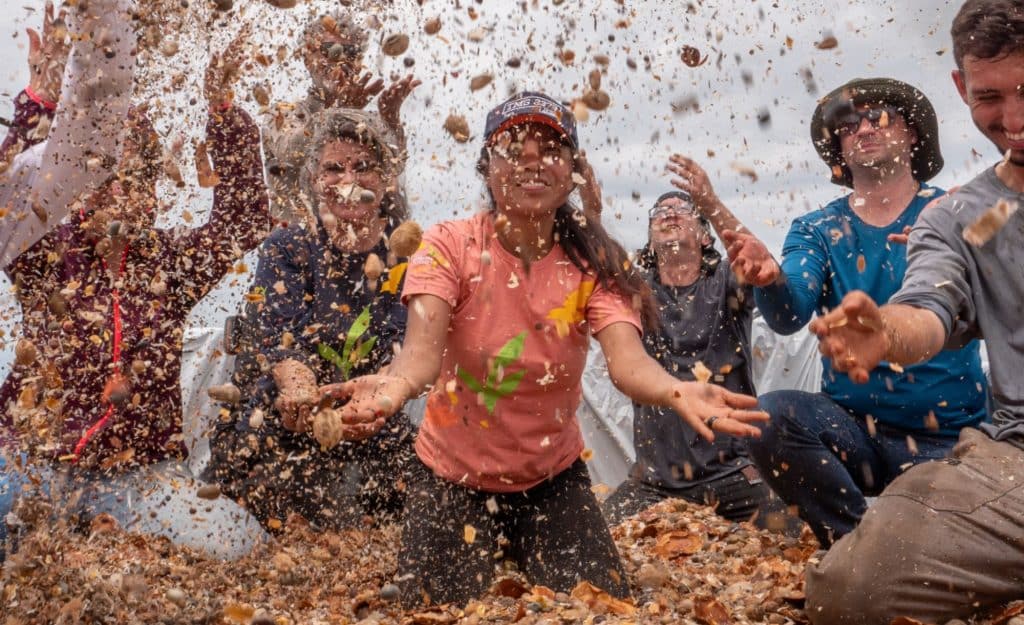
[601,466,802,533]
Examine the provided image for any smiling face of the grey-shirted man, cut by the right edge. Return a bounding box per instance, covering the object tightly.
[953,51,1024,167]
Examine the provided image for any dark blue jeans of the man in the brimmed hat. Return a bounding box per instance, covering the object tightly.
[749,390,956,548]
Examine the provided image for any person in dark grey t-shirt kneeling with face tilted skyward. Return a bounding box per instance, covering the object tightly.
[602,175,784,526]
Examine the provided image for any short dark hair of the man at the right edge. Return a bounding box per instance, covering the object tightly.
[950,0,1024,70]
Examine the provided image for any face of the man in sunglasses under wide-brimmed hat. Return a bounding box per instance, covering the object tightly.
[836,105,918,170]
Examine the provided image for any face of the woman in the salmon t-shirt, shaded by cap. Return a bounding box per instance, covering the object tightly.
[487,123,574,216]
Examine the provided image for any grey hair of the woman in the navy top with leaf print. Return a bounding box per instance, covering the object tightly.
[299,108,409,226]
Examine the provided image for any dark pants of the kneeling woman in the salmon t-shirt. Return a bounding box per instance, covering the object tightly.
[398,460,630,608]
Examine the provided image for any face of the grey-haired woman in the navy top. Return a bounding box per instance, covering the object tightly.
[313,138,388,236]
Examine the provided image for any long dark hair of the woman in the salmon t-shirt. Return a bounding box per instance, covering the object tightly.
[476,148,660,330]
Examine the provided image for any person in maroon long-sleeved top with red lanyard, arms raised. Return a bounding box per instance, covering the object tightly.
[0,41,269,557]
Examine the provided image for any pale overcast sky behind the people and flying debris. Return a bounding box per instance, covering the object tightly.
[0,0,998,346]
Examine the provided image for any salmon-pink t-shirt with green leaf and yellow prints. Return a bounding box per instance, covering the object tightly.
[402,212,641,493]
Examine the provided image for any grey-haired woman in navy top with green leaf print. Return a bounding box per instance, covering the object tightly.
[208,109,412,530]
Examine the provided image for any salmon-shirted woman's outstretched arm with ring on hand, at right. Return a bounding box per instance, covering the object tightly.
[597,315,768,441]
